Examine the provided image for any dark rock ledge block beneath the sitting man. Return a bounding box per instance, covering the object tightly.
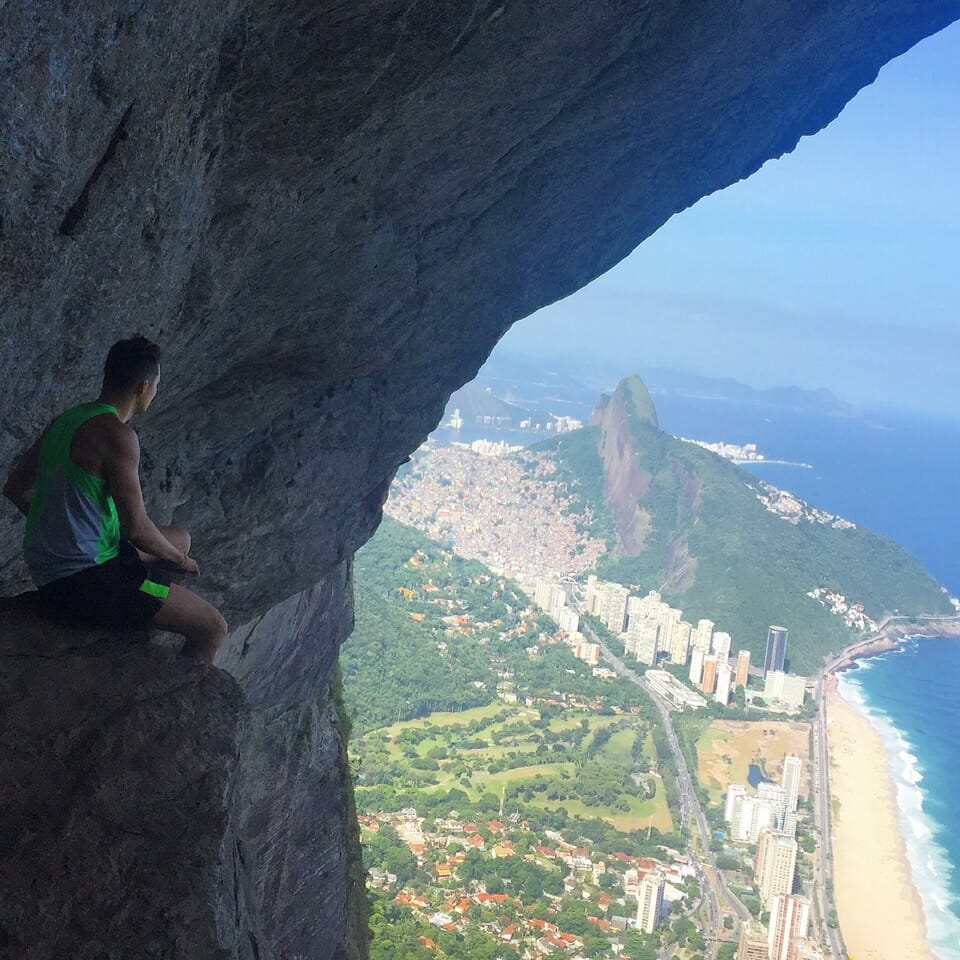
[0,608,273,960]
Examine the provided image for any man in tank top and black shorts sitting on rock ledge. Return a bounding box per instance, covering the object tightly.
[3,337,227,663]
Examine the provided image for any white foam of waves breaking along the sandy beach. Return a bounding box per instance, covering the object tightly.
[839,661,960,960]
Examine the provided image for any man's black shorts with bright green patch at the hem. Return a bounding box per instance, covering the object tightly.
[38,540,170,627]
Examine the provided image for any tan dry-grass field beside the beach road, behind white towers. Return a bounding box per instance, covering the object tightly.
[697,720,810,803]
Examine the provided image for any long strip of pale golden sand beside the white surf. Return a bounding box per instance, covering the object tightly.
[827,680,937,960]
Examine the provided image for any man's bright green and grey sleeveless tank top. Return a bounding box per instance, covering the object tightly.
[23,403,120,587]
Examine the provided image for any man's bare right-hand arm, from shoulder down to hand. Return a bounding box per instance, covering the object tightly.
[103,423,197,573]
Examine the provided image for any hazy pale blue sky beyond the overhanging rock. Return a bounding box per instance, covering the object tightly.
[502,24,960,418]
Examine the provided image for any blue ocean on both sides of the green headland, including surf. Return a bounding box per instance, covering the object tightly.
[438,384,960,960]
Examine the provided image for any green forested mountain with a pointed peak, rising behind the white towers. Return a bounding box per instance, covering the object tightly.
[538,378,951,673]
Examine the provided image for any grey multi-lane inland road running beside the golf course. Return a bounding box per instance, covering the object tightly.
[580,624,750,957]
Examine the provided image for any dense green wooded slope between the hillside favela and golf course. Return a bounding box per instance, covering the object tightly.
[340,517,656,733]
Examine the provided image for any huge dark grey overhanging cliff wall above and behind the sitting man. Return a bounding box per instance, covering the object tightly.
[0,0,960,958]
